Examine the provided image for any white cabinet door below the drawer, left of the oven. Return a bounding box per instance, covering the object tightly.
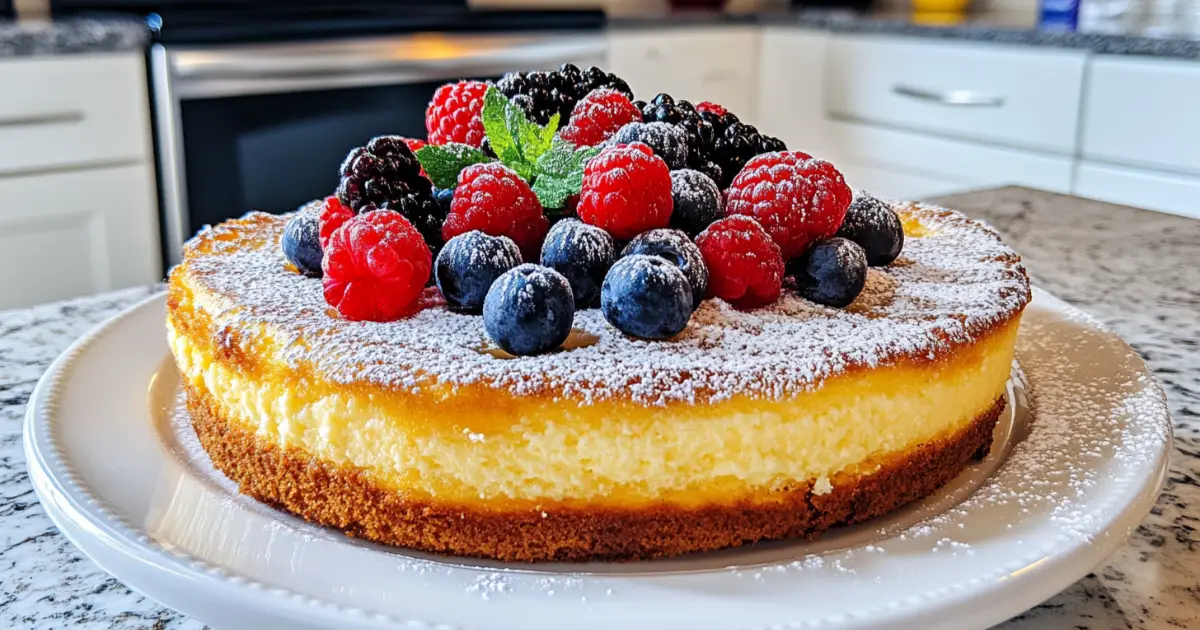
[0,166,162,308]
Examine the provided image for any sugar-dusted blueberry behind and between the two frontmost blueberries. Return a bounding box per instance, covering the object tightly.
[541,218,616,310]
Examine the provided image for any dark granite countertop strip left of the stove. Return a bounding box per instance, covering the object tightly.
[0,19,150,58]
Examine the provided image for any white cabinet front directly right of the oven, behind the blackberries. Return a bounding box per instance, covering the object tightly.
[608,26,758,122]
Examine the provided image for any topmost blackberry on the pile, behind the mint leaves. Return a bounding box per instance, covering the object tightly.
[496,64,634,127]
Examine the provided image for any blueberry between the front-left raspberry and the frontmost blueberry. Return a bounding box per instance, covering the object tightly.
[433,229,521,313]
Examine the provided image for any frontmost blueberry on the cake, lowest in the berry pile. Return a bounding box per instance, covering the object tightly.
[484,263,575,355]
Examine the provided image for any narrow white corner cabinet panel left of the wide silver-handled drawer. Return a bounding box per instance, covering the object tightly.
[755,26,835,160]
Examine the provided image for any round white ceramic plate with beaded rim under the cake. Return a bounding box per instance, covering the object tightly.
[25,292,1171,630]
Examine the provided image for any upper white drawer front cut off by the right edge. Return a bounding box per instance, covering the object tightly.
[1082,59,1200,173]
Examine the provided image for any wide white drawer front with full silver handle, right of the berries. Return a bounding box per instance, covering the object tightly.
[826,36,1086,155]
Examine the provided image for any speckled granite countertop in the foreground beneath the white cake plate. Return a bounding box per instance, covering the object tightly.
[0,187,1200,630]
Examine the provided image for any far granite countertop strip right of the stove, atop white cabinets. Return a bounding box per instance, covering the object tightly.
[610,10,1200,59]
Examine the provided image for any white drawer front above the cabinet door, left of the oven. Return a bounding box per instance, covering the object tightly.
[0,53,150,173]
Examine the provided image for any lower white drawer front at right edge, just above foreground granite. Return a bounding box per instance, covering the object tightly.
[1073,162,1200,218]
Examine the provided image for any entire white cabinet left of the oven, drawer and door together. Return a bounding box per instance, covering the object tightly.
[0,52,162,308]
